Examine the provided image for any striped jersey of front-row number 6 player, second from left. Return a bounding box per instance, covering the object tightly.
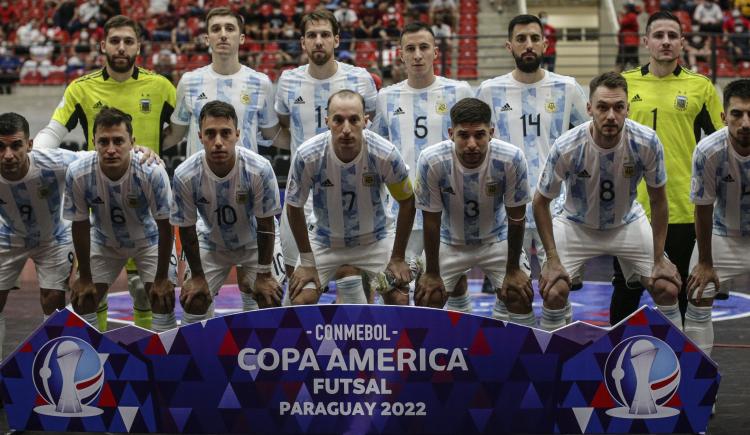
[63,153,171,248]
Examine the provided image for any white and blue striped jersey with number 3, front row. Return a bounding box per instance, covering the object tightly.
[416,139,531,245]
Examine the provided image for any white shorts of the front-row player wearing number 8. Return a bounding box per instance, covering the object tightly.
[552,215,654,282]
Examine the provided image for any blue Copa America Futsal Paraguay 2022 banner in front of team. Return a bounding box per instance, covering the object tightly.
[0,305,720,433]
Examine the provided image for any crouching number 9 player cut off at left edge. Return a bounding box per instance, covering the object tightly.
[0,113,77,360]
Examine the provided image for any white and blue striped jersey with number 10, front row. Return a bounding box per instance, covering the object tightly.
[170,148,281,251]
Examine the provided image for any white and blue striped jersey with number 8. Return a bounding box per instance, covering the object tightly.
[537,119,667,230]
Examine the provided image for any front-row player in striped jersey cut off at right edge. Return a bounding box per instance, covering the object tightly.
[685,80,750,356]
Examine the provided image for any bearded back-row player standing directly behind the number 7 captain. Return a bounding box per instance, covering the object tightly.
[274,10,377,278]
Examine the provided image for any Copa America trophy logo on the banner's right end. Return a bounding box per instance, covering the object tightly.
[604,335,680,419]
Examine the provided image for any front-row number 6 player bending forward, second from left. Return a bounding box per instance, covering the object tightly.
[63,106,176,332]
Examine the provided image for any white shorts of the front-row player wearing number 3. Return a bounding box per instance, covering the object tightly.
[440,240,531,293]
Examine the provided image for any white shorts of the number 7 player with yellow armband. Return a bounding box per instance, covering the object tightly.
[306,236,393,288]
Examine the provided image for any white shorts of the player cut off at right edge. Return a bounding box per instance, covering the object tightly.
[690,234,750,299]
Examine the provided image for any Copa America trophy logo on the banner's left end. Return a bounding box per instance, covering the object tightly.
[33,337,107,417]
